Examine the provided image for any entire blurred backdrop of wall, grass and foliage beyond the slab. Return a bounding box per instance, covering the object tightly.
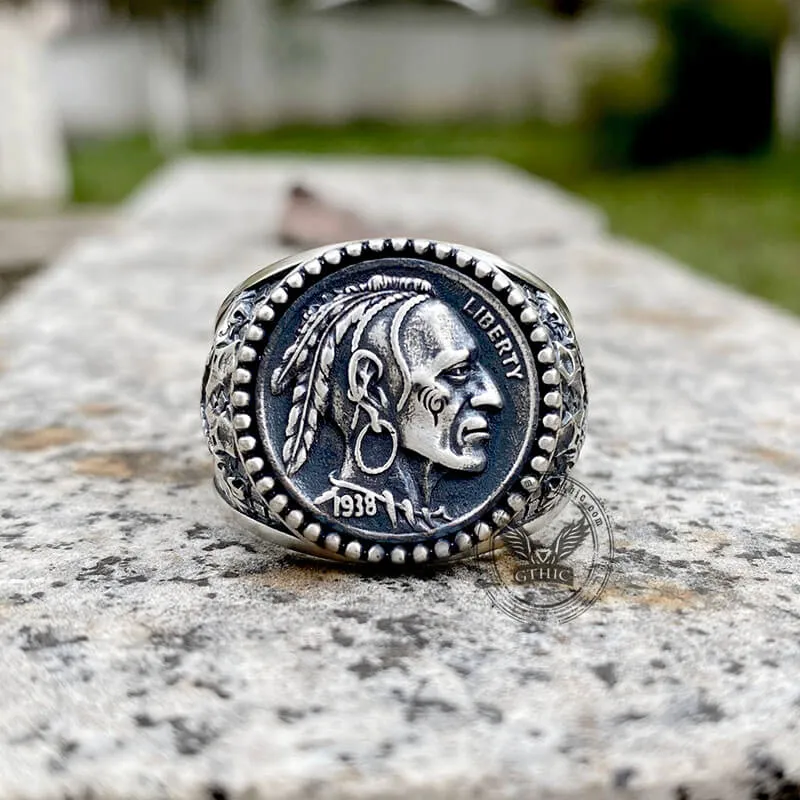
[0,0,800,313]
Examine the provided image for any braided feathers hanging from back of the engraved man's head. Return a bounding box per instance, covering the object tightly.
[270,275,433,475]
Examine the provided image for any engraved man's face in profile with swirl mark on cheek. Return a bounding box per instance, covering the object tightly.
[398,300,503,472]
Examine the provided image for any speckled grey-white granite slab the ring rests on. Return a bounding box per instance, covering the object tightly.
[0,161,800,800]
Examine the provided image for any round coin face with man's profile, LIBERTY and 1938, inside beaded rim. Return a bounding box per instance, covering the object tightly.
[261,262,536,538]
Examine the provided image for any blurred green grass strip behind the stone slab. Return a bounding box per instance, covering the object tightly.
[71,122,800,313]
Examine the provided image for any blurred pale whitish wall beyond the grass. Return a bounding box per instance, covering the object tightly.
[45,7,653,134]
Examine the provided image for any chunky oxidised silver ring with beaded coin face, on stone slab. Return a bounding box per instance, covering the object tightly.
[201,238,586,564]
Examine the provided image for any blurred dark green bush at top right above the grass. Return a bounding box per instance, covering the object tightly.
[587,0,789,166]
